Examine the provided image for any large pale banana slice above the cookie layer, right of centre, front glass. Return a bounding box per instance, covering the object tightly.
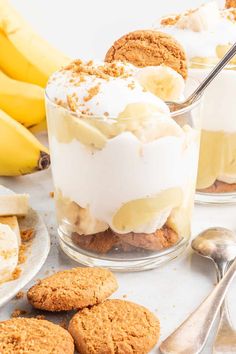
[112,187,183,233]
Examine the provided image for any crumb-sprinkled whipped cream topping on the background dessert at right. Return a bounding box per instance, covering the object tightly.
[155,1,236,59]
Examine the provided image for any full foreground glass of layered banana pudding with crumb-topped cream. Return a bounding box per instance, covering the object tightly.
[46,60,203,270]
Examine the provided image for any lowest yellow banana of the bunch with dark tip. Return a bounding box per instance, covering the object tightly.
[0,110,50,176]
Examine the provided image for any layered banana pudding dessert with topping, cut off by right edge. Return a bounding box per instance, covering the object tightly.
[158,1,236,203]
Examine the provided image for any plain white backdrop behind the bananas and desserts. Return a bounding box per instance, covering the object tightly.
[11,0,225,59]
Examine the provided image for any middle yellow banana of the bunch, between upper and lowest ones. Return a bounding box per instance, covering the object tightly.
[0,70,45,127]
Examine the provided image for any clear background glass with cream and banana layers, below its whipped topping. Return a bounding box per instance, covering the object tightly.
[191,58,236,204]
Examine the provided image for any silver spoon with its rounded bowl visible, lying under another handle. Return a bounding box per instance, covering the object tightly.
[192,227,236,354]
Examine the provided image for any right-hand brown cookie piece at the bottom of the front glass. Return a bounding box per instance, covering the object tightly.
[120,227,179,251]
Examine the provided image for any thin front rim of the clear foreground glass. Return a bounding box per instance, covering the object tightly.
[45,77,204,122]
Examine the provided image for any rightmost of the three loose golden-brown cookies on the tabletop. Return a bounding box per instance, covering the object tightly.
[68,300,160,354]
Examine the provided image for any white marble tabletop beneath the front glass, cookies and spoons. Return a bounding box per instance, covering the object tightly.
[0,170,236,354]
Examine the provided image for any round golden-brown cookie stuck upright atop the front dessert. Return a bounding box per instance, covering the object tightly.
[105,30,187,79]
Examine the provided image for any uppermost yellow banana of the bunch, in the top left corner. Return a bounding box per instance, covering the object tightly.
[0,0,70,87]
